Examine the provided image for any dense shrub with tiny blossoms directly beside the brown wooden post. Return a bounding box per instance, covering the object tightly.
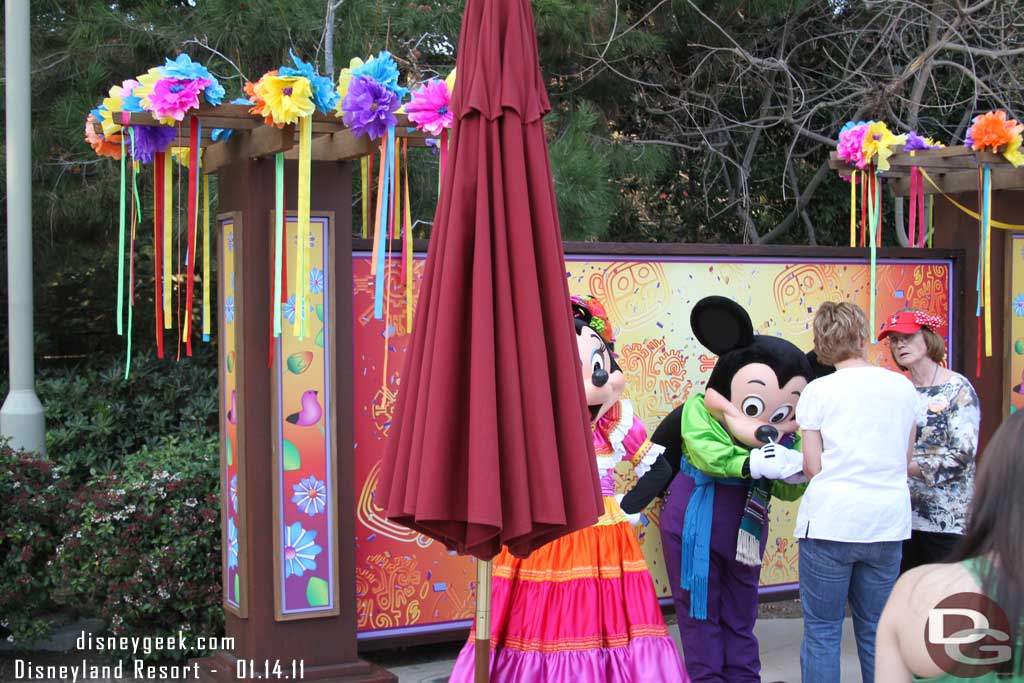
[50,436,223,657]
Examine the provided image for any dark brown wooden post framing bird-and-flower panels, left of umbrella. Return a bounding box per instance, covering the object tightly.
[192,157,395,683]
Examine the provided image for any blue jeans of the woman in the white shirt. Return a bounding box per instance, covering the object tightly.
[800,539,903,683]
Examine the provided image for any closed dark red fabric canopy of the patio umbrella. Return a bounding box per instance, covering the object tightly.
[377,0,603,565]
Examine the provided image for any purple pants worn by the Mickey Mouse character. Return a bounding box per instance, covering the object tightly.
[660,473,768,683]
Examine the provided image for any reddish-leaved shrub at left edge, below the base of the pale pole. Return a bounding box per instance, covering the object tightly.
[0,444,71,648]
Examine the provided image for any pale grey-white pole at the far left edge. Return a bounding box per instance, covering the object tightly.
[0,0,46,453]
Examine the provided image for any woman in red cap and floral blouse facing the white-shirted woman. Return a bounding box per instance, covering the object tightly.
[879,309,981,571]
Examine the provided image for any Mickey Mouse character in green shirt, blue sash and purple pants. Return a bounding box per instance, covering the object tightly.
[622,296,814,683]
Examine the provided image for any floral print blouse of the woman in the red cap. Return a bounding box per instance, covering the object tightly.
[910,373,981,533]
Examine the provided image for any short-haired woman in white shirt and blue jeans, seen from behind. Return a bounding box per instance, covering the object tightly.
[796,302,918,683]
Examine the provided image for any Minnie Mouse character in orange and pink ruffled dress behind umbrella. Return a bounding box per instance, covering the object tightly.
[450,296,689,683]
